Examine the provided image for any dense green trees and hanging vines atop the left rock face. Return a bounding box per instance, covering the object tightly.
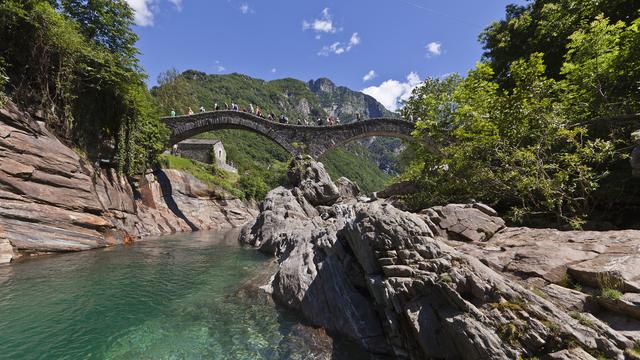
[0,0,167,175]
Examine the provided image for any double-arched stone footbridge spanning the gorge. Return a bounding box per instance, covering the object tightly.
[162,110,438,159]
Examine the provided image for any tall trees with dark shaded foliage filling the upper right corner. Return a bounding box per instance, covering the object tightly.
[472,0,640,226]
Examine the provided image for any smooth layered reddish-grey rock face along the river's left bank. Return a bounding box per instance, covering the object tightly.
[0,104,255,263]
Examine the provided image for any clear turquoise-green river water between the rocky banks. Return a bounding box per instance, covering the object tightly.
[0,232,364,359]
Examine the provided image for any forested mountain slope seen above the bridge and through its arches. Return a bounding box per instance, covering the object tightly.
[151,70,401,192]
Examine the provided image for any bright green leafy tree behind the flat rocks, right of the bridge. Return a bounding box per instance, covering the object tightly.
[404,54,613,228]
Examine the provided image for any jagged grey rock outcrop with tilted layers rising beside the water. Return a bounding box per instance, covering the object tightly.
[241,158,637,359]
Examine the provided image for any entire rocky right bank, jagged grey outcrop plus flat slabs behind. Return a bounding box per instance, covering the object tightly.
[241,158,640,359]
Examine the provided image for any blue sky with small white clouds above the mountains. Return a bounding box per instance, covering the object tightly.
[127,0,525,110]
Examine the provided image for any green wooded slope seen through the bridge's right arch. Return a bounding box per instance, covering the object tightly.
[320,143,391,193]
